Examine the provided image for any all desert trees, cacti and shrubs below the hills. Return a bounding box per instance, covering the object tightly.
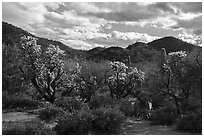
[2,37,202,135]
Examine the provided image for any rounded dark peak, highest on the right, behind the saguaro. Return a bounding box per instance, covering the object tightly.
[147,36,195,53]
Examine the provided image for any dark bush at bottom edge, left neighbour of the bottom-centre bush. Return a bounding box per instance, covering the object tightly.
[54,110,93,135]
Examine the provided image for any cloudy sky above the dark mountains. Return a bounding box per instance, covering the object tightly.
[2,2,202,50]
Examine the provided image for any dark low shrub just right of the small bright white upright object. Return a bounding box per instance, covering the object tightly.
[151,106,177,125]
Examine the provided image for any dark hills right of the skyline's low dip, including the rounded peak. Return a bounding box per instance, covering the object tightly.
[88,37,197,63]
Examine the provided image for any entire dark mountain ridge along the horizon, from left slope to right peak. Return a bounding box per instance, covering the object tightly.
[2,22,198,63]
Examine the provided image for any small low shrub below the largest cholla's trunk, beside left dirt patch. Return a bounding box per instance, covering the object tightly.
[39,106,64,122]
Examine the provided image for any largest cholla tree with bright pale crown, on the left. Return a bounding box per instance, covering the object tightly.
[19,36,64,103]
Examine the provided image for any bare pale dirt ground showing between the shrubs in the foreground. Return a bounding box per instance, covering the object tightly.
[2,112,191,135]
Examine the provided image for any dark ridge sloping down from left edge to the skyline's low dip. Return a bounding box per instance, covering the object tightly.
[2,22,86,58]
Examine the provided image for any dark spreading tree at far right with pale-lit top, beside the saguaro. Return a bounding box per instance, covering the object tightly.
[157,48,202,114]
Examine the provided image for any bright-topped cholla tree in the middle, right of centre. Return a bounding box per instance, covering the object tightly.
[107,62,144,99]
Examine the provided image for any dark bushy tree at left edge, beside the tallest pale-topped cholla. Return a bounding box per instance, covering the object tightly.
[2,44,27,93]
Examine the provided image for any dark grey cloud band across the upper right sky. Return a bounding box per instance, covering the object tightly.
[84,2,202,22]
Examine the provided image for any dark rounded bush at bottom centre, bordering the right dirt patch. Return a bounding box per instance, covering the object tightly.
[92,107,124,135]
